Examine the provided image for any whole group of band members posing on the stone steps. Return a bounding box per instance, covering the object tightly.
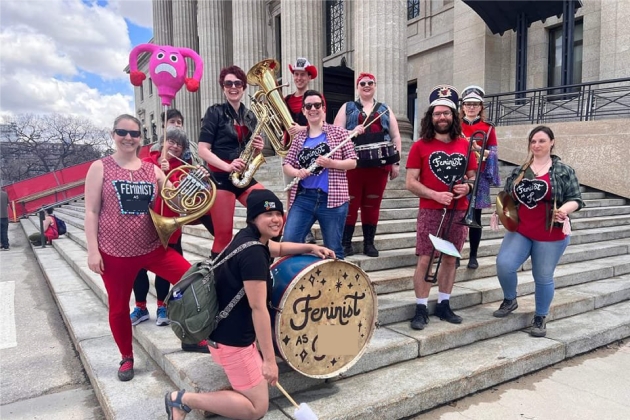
[85,58,583,419]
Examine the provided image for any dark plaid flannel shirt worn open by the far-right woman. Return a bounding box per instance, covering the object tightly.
[504,155,584,211]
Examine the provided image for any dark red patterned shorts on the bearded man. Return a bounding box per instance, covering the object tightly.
[416,209,468,255]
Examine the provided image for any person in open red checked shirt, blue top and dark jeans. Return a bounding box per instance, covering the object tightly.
[282,90,357,259]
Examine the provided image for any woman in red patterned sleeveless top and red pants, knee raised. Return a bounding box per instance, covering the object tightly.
[85,114,202,381]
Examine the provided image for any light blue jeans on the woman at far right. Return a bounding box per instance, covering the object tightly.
[497,232,571,316]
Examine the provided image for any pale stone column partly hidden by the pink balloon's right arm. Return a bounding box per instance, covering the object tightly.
[173,0,203,141]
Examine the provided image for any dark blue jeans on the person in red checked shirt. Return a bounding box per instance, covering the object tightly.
[282,188,348,259]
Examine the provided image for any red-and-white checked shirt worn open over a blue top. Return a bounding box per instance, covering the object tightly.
[283,123,357,208]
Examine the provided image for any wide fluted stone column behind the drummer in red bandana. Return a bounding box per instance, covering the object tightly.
[352,0,412,140]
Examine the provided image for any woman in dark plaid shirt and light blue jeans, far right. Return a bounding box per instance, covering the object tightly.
[493,125,584,337]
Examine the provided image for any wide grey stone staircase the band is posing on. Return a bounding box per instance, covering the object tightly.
[22,158,630,419]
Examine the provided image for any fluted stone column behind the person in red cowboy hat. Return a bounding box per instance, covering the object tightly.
[281,0,325,93]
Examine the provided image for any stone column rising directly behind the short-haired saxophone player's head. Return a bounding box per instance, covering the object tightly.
[197,1,232,110]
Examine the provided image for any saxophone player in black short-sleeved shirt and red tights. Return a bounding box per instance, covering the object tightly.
[199,66,264,258]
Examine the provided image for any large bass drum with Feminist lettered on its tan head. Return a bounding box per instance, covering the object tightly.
[271,255,378,379]
